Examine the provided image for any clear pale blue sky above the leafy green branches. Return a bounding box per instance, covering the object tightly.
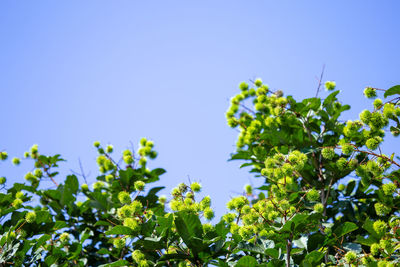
[0,0,400,219]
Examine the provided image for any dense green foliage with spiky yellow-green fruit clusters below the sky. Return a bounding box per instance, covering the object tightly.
[0,82,400,266]
